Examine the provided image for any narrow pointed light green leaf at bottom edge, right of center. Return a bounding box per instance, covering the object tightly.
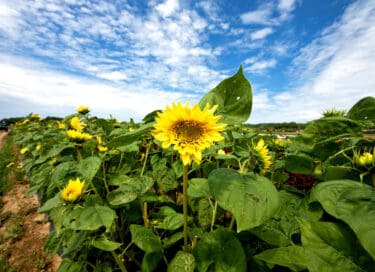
[254,246,308,271]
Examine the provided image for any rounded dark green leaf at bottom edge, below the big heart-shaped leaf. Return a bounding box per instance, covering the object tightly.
[193,229,246,272]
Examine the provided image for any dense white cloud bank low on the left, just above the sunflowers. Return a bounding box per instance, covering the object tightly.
[0,56,197,121]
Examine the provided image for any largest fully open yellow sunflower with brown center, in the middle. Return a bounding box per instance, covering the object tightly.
[152,103,226,165]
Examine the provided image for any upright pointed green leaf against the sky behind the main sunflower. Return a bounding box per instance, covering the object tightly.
[199,66,253,124]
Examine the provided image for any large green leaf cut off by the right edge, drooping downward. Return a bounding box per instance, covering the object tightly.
[311,180,375,259]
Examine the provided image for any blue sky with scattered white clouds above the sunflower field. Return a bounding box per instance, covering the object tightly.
[0,0,375,124]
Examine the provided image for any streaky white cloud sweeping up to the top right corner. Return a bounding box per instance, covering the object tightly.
[250,1,375,123]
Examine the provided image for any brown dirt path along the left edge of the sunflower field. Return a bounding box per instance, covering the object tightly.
[0,131,61,272]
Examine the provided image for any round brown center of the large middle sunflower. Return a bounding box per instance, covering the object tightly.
[173,120,204,142]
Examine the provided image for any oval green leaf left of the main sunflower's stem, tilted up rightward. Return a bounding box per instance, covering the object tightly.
[107,176,154,206]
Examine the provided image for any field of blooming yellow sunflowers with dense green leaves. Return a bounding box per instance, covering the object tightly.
[3,68,375,272]
